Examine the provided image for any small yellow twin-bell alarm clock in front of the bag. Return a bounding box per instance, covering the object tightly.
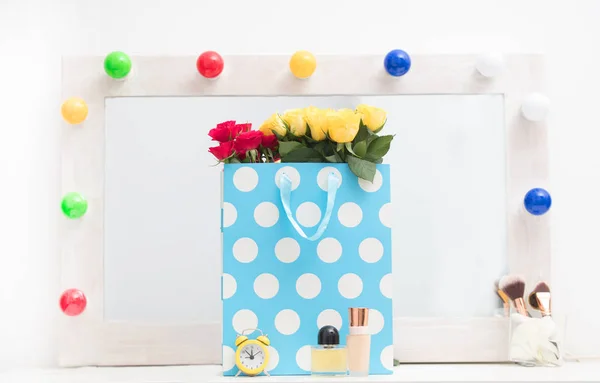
[235,328,271,376]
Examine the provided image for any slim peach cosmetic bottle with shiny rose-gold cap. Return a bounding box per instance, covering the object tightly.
[346,307,371,376]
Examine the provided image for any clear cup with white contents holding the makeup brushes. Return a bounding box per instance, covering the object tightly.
[509,310,566,367]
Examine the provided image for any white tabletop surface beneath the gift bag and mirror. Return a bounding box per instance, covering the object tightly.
[0,361,600,383]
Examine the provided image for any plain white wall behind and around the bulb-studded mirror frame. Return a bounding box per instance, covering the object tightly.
[0,0,600,367]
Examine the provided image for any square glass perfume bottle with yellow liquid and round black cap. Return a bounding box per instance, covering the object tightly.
[311,326,348,376]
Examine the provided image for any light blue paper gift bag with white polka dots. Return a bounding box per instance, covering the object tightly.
[222,163,393,375]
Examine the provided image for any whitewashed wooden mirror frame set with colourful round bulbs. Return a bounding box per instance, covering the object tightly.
[59,55,550,366]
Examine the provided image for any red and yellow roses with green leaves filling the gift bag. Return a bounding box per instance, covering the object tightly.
[209,105,394,182]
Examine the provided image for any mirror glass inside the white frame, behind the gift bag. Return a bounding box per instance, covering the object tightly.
[104,95,508,323]
